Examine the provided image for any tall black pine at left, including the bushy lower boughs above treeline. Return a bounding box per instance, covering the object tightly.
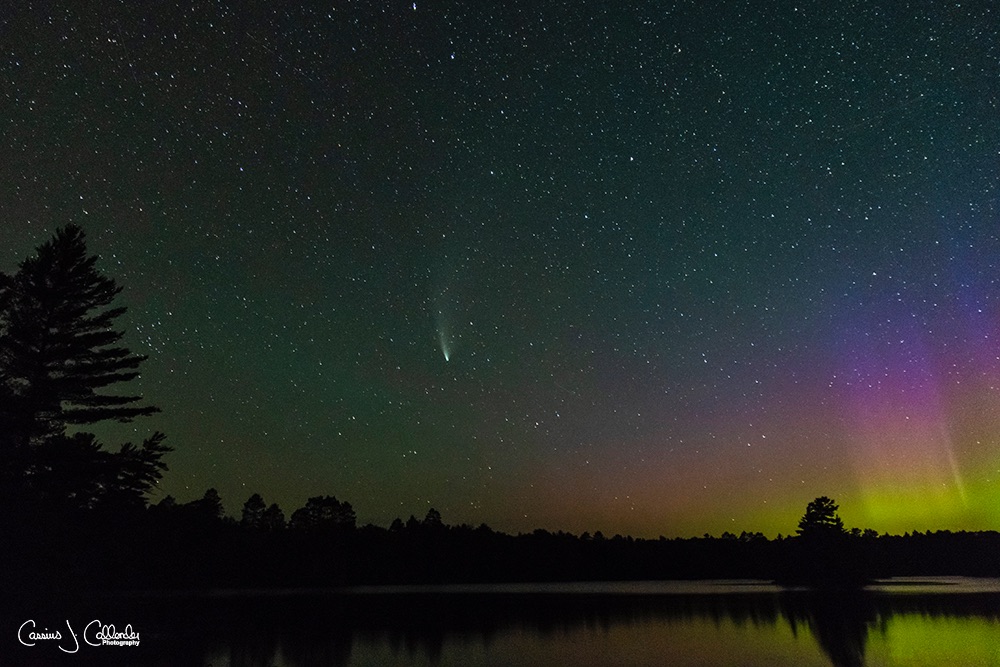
[0,225,170,507]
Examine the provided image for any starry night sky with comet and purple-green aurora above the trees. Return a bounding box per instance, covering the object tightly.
[0,0,1000,537]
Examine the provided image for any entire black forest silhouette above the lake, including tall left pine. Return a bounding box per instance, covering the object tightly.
[0,226,1000,591]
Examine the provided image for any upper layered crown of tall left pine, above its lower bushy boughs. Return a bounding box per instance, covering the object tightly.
[0,225,158,446]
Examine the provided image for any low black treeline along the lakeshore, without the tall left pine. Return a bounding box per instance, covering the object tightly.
[5,490,1000,590]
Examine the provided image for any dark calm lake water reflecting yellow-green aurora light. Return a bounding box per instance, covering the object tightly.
[11,578,1000,667]
